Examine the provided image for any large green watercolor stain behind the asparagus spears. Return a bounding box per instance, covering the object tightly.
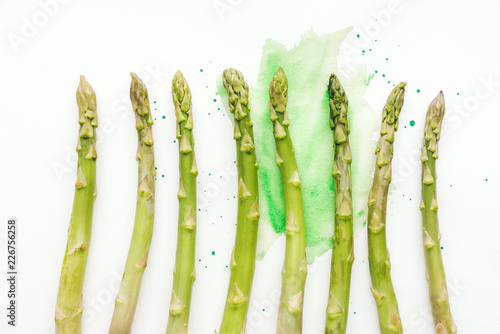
[216,28,379,263]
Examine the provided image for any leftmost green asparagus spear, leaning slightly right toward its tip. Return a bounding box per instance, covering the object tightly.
[55,76,97,334]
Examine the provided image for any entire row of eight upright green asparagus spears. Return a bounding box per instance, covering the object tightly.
[55,68,456,334]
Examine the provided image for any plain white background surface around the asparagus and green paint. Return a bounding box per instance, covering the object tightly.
[0,0,500,334]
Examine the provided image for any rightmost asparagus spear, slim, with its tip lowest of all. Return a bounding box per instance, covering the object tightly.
[420,91,457,334]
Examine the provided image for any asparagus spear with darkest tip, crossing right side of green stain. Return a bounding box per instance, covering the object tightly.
[325,74,354,334]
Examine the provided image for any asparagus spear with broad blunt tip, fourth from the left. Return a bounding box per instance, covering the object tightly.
[220,68,260,334]
